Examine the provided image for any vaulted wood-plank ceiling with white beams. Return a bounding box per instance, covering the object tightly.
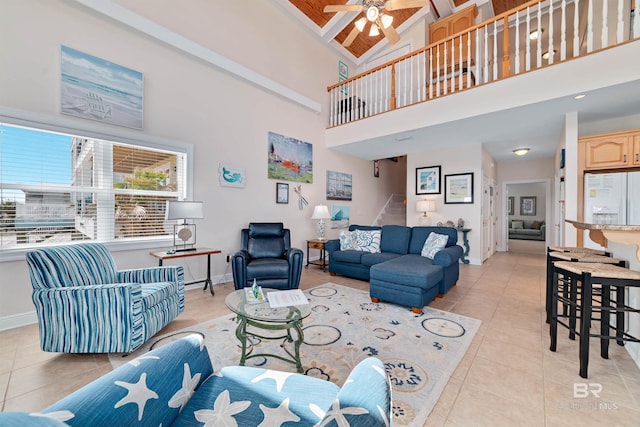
[277,0,526,64]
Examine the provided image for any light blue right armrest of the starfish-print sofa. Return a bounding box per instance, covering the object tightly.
[320,357,393,427]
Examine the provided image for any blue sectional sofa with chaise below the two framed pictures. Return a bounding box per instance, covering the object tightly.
[325,225,463,312]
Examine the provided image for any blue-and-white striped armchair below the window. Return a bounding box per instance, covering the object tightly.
[26,243,184,353]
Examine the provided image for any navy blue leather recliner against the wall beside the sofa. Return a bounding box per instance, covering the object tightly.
[231,222,304,289]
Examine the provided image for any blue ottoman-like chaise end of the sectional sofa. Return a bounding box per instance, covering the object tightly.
[369,254,443,313]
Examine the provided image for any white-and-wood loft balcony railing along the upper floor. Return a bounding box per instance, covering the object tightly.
[327,0,640,127]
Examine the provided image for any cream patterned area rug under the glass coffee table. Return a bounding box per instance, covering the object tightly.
[110,283,480,426]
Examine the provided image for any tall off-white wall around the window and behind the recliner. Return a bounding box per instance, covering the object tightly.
[0,0,405,328]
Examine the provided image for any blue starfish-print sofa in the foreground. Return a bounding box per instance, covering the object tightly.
[0,334,392,427]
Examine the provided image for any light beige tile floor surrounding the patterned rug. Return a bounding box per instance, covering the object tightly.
[0,252,640,427]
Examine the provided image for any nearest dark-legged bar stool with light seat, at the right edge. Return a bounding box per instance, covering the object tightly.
[549,261,640,378]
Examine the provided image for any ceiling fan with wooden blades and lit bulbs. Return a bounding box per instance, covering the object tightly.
[324,0,428,47]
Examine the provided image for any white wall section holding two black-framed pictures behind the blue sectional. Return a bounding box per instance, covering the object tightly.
[407,141,482,265]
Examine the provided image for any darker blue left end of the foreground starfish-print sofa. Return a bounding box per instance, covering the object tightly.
[42,334,213,427]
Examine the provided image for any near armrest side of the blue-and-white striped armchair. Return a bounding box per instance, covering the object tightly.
[31,283,144,353]
